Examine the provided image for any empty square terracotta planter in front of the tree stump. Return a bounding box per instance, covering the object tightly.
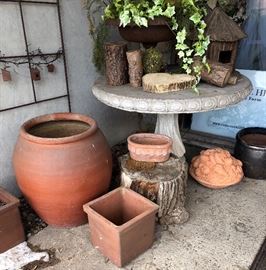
[83,187,159,267]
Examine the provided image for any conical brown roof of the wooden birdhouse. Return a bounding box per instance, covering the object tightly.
[206,7,246,42]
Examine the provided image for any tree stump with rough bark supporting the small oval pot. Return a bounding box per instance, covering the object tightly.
[120,154,189,225]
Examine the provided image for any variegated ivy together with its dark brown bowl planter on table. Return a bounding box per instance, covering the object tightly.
[84,0,209,92]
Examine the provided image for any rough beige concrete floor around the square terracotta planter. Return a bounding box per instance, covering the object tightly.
[29,176,266,270]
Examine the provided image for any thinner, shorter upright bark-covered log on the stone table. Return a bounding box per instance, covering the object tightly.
[126,50,143,87]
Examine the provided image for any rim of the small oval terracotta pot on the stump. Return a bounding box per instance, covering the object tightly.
[127,133,173,149]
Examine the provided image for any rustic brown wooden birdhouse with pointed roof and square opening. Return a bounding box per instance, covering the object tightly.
[205,7,246,69]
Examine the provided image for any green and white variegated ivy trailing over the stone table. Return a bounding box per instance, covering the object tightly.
[103,0,210,93]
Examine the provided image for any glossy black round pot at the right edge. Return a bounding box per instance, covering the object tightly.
[234,127,266,179]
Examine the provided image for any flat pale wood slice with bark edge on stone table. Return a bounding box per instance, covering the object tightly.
[142,73,196,93]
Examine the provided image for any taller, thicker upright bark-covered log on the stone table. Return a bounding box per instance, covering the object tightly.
[104,42,128,86]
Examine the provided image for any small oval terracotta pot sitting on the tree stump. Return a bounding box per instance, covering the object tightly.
[127,133,173,162]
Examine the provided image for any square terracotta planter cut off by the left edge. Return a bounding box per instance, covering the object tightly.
[0,187,25,253]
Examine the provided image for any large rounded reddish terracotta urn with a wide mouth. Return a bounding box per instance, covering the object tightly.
[13,113,112,227]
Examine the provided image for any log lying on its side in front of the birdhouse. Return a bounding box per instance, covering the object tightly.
[201,61,232,87]
